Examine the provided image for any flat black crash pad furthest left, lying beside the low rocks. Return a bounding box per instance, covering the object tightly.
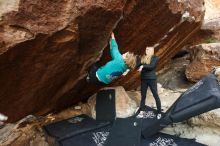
[43,115,110,144]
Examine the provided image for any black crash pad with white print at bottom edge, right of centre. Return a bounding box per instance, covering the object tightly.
[140,133,206,146]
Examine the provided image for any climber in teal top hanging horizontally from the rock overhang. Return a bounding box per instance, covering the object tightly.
[86,33,136,85]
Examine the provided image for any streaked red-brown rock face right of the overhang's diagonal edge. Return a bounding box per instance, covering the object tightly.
[102,0,204,90]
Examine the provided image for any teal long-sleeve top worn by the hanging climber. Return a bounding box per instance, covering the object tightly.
[96,39,128,84]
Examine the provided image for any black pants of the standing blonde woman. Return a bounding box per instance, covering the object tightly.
[140,79,161,113]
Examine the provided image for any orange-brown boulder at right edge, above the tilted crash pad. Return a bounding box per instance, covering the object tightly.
[186,43,220,82]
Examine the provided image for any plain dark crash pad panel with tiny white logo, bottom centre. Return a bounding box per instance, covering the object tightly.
[105,117,142,146]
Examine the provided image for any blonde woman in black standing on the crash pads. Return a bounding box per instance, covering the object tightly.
[138,47,161,119]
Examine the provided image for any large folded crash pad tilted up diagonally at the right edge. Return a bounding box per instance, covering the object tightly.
[142,74,220,138]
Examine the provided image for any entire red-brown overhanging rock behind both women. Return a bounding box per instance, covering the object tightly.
[0,0,204,121]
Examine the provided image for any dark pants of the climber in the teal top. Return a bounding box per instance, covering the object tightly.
[87,64,104,85]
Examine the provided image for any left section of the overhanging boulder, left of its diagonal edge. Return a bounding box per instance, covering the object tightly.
[0,0,125,121]
